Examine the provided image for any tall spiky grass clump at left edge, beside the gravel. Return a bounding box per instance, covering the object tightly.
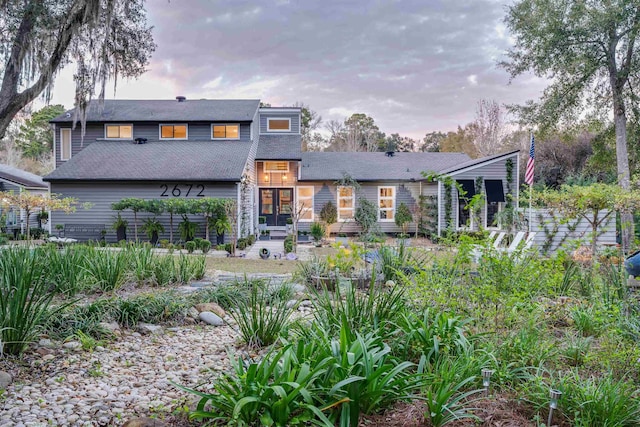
[0,248,63,355]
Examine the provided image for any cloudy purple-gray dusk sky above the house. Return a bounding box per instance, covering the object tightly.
[52,0,545,138]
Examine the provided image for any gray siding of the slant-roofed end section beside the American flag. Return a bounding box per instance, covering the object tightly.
[436,153,519,233]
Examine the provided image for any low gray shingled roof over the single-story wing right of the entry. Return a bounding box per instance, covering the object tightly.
[300,151,469,181]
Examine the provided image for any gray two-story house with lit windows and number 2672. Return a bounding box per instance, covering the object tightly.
[44,97,518,241]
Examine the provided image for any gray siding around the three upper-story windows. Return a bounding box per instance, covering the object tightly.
[55,122,251,167]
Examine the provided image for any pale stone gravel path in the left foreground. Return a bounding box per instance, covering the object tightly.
[0,326,237,426]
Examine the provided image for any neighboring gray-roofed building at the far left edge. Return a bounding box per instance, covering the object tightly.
[0,164,51,235]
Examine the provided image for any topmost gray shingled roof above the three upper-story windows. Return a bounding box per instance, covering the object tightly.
[51,99,260,123]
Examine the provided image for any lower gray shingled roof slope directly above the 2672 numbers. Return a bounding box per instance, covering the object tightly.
[44,141,251,181]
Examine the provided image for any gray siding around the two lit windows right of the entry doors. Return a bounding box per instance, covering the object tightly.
[299,181,420,233]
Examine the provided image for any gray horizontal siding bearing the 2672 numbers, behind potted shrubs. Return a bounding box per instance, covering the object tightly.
[50,182,238,242]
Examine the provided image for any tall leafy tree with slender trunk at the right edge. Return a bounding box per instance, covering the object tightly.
[501,0,640,250]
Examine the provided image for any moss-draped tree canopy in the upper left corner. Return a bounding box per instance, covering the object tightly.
[0,0,155,138]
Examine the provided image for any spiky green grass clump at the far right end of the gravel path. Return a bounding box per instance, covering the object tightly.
[229,280,293,348]
